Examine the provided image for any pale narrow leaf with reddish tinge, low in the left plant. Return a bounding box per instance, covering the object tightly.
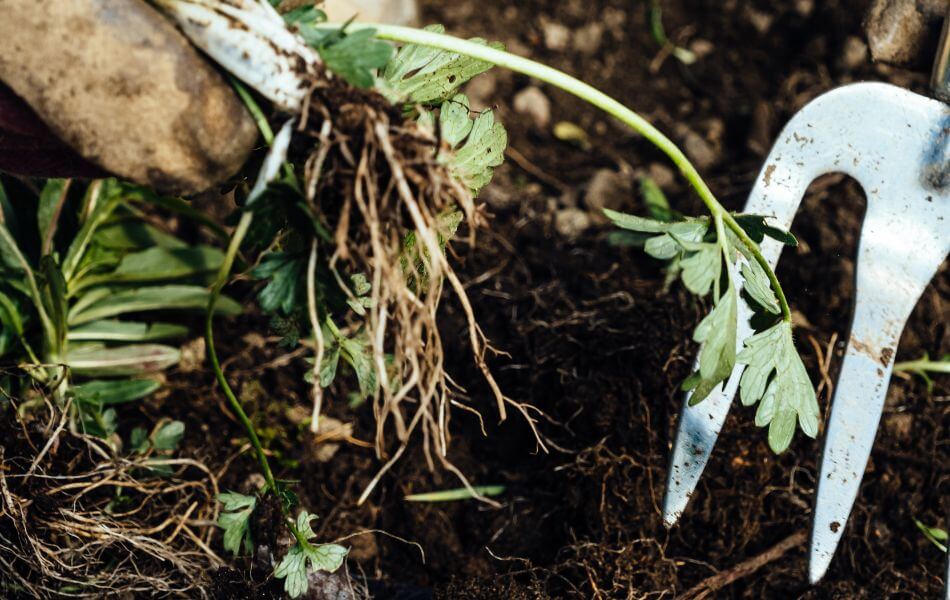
[63,344,181,377]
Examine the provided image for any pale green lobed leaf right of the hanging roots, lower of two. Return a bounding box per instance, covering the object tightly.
[439,94,508,193]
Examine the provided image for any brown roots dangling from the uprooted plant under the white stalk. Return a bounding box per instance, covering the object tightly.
[300,80,545,503]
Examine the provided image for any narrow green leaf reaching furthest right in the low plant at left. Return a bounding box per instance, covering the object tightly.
[69,285,241,327]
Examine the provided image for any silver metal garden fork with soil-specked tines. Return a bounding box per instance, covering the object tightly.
[663,11,950,583]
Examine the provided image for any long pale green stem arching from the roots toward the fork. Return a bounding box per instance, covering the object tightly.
[319,23,792,321]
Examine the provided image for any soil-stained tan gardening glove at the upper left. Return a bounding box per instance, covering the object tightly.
[0,0,257,194]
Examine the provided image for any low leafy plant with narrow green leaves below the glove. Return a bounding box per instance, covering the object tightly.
[0,179,240,450]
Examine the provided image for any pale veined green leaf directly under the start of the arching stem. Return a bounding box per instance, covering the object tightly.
[380,25,505,104]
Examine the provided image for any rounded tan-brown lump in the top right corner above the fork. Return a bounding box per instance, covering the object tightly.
[864,0,946,67]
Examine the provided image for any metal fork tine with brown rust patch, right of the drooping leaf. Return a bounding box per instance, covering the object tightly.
[808,202,950,583]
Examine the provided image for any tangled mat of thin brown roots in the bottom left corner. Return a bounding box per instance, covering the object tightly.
[0,398,223,598]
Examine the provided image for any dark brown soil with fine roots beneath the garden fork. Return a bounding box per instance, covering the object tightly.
[195,0,950,599]
